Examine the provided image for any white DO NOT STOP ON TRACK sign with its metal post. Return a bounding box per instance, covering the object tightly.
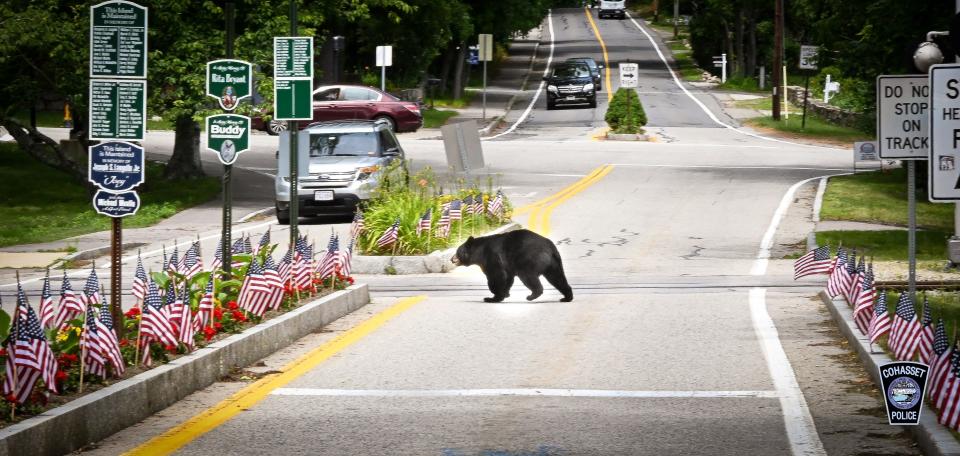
[877,75,930,300]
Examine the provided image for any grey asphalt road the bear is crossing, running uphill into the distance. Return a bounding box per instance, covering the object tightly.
[62,9,915,456]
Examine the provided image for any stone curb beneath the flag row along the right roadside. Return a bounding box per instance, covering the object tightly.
[818,291,960,456]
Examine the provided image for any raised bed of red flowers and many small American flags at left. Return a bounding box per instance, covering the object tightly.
[0,232,354,427]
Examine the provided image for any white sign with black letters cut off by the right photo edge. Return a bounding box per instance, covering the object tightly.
[928,64,960,202]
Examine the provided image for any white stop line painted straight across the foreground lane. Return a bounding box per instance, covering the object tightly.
[270,388,777,398]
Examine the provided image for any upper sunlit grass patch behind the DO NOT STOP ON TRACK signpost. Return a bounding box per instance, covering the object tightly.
[820,168,954,232]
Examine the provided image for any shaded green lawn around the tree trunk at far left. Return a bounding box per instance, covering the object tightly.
[0,143,220,246]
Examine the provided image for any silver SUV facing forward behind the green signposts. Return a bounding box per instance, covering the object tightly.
[275,120,404,224]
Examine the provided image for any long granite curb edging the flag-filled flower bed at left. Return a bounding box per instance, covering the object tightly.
[0,284,370,456]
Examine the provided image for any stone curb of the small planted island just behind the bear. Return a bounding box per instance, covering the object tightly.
[350,222,523,275]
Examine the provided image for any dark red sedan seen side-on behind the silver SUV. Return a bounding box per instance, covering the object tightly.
[252,85,423,135]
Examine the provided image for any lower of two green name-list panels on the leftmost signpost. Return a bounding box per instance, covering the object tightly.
[89,79,147,141]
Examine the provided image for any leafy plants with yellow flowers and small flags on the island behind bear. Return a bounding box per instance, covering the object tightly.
[354,163,512,255]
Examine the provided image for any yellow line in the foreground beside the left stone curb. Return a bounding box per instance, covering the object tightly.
[126,296,426,455]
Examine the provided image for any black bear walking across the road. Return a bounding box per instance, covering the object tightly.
[450,230,573,302]
